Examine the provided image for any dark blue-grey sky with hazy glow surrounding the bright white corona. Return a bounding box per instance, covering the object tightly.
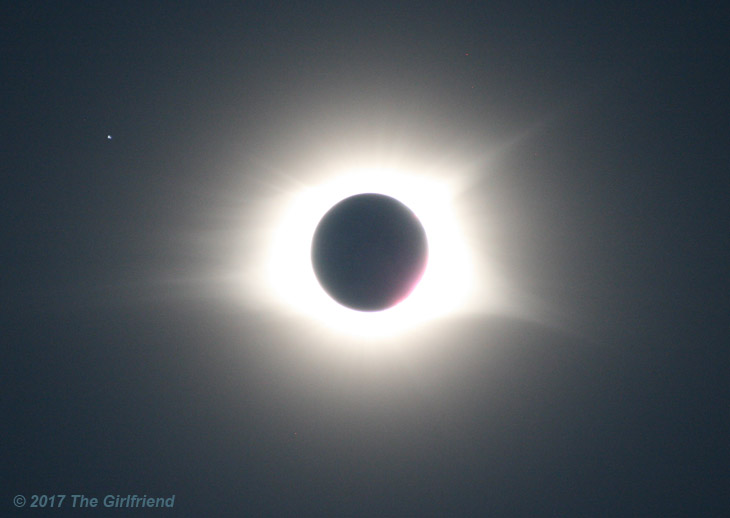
[0,1,730,517]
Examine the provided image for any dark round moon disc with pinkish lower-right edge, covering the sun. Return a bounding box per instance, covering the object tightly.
[312,194,428,311]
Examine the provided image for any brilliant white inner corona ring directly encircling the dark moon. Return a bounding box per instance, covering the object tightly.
[266,167,475,338]
